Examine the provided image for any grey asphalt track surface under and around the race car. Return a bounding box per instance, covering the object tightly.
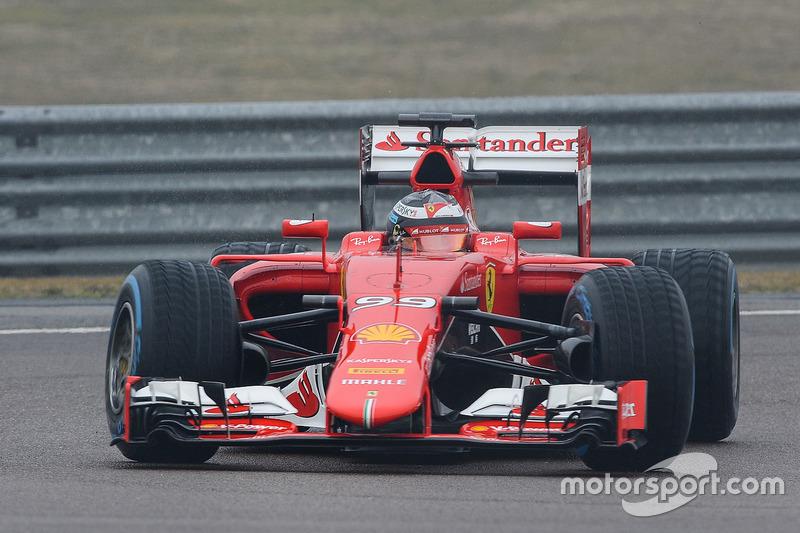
[0,294,800,533]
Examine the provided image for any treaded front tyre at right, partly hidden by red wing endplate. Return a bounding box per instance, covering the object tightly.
[562,267,694,471]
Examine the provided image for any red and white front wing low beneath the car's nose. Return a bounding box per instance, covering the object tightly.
[111,376,647,451]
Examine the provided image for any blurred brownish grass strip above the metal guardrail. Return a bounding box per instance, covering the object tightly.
[0,0,800,106]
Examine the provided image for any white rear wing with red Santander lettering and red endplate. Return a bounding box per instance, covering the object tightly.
[360,120,591,257]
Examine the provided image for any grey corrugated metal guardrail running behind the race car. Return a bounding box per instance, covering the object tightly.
[0,92,800,275]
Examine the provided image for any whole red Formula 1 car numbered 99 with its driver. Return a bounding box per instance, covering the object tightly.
[105,113,739,470]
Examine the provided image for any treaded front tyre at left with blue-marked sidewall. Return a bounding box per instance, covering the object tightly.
[105,261,242,463]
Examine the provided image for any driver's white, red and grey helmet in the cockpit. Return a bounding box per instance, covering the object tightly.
[386,189,469,252]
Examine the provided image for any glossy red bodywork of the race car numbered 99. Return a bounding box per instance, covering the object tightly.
[202,119,639,443]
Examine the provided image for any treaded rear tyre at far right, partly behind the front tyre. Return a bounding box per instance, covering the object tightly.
[633,249,740,442]
